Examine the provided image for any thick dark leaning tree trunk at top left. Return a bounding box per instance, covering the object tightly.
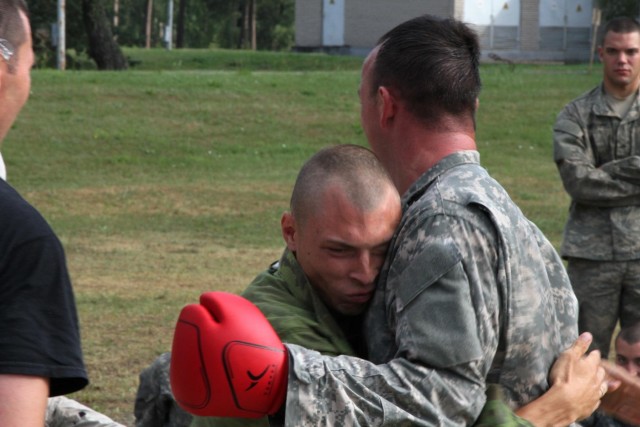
[82,0,127,70]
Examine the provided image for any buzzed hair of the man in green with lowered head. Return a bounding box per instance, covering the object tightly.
[290,144,395,223]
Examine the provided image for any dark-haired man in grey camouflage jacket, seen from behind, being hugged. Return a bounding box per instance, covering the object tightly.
[278,16,606,426]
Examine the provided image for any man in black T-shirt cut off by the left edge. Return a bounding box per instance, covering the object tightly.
[0,0,88,427]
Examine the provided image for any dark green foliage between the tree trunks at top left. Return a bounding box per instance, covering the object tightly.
[29,0,294,66]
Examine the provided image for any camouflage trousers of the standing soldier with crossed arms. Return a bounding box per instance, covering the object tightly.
[567,258,640,359]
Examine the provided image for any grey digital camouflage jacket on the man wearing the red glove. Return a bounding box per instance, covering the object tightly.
[286,151,578,426]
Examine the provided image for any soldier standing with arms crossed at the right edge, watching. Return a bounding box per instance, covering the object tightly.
[553,18,640,358]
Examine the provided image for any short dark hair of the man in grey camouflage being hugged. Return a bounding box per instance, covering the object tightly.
[369,15,482,126]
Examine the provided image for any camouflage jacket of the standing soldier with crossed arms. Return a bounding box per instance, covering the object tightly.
[553,86,640,261]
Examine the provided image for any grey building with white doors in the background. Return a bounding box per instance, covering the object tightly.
[295,0,593,62]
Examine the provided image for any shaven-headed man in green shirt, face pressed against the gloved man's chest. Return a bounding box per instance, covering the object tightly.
[159,145,600,427]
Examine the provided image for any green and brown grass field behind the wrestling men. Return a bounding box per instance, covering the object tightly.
[2,49,600,425]
